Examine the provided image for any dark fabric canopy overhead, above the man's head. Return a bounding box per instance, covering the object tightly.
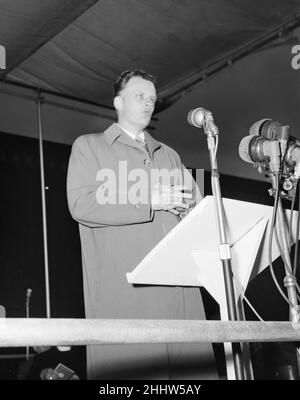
[0,0,300,109]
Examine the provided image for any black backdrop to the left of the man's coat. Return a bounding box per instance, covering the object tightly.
[0,133,85,379]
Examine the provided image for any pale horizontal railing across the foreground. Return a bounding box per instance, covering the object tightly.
[0,318,300,347]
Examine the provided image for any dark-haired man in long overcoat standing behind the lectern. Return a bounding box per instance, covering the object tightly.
[67,70,217,379]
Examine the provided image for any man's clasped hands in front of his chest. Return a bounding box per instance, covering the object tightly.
[151,184,194,215]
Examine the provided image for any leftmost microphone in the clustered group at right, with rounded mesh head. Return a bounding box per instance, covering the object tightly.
[239,135,280,172]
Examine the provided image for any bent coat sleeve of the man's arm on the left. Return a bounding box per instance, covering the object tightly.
[67,136,153,228]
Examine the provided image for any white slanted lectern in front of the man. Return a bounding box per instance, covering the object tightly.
[127,196,297,308]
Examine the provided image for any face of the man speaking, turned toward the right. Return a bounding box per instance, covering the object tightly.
[115,76,156,129]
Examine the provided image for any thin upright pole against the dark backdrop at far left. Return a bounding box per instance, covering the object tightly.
[37,91,50,318]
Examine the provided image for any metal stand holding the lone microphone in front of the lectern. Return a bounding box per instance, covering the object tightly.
[203,120,245,380]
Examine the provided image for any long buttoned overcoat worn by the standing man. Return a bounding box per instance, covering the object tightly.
[67,124,216,379]
